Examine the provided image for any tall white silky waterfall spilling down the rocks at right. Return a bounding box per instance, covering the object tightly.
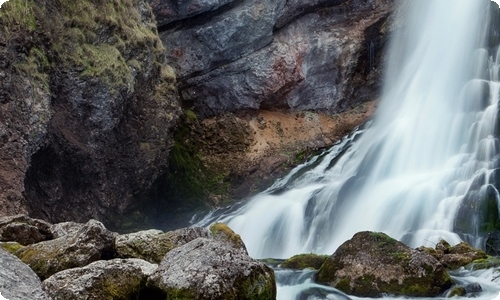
[195,0,500,258]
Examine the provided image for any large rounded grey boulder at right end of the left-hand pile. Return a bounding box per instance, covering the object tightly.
[148,225,276,300]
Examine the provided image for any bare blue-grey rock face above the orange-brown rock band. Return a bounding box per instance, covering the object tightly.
[150,0,394,116]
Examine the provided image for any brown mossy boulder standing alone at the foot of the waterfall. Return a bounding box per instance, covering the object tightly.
[317,231,453,297]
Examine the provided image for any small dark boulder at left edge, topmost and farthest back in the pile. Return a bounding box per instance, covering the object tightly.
[0,215,53,245]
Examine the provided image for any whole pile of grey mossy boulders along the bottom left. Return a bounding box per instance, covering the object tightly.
[0,216,276,300]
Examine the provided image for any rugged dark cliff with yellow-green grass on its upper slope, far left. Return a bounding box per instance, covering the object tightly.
[0,0,179,227]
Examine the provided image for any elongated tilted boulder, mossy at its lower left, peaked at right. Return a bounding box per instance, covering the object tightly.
[15,220,116,280]
